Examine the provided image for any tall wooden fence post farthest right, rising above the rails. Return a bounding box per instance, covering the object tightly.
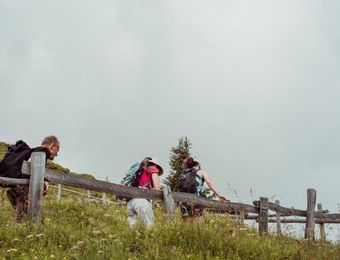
[305,189,316,242]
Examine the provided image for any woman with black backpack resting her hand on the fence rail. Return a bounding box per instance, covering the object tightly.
[179,157,229,220]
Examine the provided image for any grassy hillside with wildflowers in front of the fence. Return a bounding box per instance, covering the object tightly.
[0,143,340,259]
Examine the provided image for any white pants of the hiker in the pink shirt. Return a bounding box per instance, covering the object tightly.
[127,198,154,227]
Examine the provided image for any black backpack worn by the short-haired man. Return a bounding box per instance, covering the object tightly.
[0,140,32,178]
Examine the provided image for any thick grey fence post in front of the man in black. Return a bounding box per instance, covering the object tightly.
[27,152,46,225]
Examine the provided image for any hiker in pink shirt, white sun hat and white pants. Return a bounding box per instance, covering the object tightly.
[127,157,163,227]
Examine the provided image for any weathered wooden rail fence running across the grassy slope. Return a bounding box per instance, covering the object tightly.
[0,152,340,241]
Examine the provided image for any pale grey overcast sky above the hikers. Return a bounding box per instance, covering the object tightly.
[0,0,340,212]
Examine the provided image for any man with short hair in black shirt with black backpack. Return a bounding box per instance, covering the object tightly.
[0,135,60,224]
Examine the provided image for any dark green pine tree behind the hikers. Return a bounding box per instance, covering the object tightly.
[164,137,191,191]
